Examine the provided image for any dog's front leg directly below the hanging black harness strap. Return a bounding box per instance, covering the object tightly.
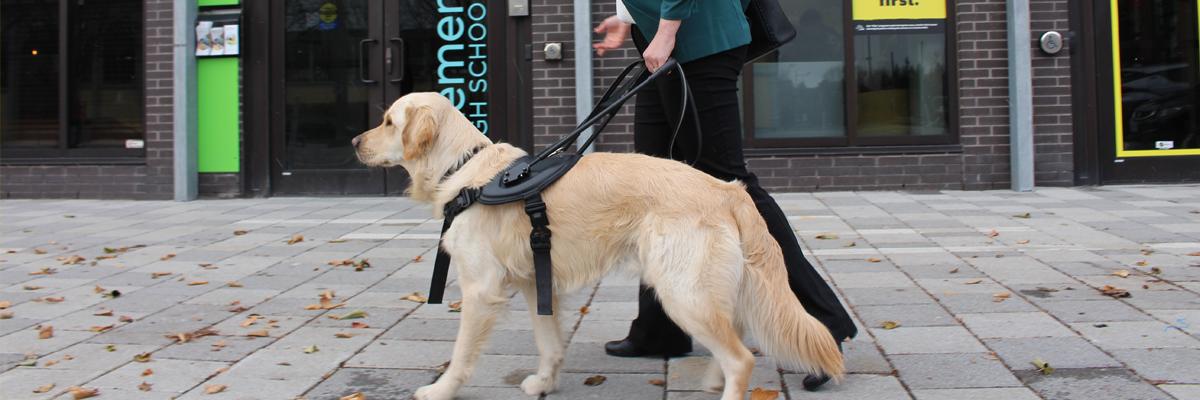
[521,283,563,395]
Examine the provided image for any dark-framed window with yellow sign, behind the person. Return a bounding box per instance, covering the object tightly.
[742,0,956,148]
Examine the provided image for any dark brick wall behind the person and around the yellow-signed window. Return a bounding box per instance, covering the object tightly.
[533,0,1073,191]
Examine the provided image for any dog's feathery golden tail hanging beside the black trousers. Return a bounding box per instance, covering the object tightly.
[733,190,845,380]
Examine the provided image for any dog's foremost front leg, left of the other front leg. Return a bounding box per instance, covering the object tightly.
[413,257,508,400]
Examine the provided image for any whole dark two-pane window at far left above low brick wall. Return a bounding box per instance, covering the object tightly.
[0,0,145,161]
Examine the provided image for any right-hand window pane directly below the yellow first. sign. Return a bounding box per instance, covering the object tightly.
[854,32,947,137]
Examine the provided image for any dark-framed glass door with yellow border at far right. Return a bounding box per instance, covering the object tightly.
[1098,0,1200,183]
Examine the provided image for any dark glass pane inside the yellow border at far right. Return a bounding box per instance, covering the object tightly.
[1117,0,1200,150]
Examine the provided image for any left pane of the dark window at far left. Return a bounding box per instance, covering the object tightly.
[0,0,59,148]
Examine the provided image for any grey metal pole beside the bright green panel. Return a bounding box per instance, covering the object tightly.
[172,0,199,202]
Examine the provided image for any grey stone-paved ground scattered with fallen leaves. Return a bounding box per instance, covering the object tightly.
[0,185,1200,400]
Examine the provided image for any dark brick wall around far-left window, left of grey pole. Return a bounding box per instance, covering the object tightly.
[0,0,174,199]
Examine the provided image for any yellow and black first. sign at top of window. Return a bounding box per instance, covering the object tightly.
[853,0,946,35]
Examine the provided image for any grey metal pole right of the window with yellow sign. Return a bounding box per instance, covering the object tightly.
[1008,0,1033,192]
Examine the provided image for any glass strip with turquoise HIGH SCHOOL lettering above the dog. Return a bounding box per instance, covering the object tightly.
[434,0,491,135]
